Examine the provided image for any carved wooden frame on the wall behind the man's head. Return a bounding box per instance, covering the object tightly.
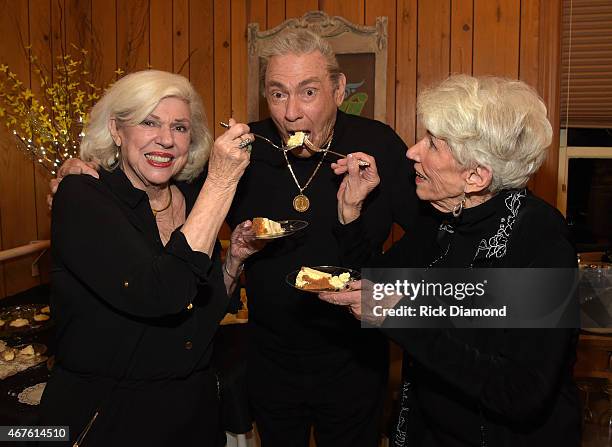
[247,11,388,122]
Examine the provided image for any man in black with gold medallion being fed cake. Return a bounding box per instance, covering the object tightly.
[52,30,418,447]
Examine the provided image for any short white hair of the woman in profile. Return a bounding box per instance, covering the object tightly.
[417,75,553,192]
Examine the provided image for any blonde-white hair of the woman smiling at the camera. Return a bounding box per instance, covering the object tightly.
[80,70,213,181]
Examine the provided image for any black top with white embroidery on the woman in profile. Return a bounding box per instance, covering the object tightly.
[336,190,580,447]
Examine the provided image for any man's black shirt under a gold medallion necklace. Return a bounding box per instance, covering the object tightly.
[227,111,417,352]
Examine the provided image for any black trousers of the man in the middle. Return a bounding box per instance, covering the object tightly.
[247,342,388,447]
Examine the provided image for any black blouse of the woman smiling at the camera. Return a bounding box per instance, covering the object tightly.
[51,169,228,380]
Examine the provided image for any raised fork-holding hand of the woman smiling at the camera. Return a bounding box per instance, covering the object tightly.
[206,118,255,188]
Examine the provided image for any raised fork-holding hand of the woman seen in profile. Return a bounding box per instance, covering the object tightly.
[332,152,380,224]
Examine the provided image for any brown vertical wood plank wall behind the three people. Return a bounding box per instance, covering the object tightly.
[0,0,561,297]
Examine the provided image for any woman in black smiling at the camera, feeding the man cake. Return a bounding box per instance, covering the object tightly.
[41,70,252,446]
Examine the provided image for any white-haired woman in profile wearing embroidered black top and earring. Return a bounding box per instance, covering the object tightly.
[321,75,580,447]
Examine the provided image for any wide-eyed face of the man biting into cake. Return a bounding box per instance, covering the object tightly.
[265,51,346,157]
